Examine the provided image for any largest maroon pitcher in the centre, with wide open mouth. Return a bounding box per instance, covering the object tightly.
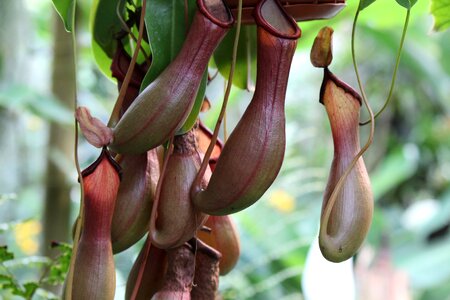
[192,0,300,215]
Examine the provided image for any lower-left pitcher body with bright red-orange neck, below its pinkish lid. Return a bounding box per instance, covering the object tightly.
[72,149,120,300]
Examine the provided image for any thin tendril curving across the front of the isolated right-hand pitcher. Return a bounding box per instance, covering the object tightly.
[320,8,375,241]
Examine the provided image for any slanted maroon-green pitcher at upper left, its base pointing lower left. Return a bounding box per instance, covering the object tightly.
[110,0,233,153]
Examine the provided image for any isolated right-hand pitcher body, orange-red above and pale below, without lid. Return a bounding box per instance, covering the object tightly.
[319,68,373,262]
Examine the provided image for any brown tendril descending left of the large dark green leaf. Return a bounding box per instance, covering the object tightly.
[108,0,147,127]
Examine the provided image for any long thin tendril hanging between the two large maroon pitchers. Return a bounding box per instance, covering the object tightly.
[192,0,242,187]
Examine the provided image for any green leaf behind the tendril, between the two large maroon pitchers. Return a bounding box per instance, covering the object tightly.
[214,26,256,89]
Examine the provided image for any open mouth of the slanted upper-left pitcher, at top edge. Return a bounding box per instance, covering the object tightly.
[197,0,234,28]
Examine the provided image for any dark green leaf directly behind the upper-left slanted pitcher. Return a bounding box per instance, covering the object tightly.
[141,0,197,90]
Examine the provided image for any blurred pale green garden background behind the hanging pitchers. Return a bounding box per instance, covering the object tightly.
[0,0,450,300]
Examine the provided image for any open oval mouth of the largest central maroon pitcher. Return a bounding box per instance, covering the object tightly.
[253,0,301,40]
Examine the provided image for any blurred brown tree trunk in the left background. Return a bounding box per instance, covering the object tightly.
[43,13,76,256]
